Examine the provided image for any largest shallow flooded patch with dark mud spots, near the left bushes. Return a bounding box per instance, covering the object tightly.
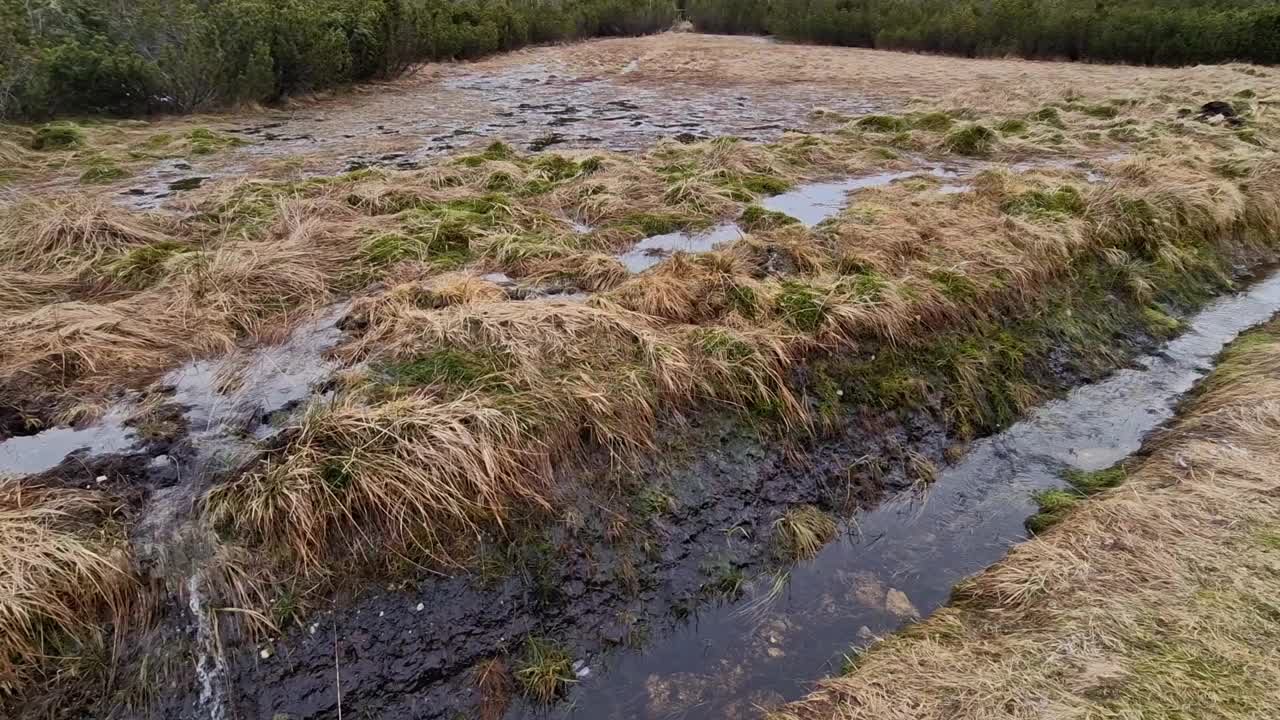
[102,38,880,209]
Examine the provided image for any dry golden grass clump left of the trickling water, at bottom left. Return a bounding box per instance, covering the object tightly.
[0,479,134,692]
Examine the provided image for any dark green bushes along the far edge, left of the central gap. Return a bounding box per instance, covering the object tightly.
[0,0,677,118]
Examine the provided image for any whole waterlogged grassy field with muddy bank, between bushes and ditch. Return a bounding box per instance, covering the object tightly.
[0,33,1280,719]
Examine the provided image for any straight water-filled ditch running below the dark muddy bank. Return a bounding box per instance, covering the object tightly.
[535,269,1280,720]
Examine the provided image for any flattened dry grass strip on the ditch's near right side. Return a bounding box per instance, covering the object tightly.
[773,317,1280,720]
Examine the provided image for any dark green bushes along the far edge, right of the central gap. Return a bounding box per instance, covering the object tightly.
[686,0,1280,65]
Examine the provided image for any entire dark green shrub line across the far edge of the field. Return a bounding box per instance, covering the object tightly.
[0,0,1280,118]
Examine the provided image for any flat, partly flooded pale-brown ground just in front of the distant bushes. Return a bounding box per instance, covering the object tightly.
[10,33,1259,210]
